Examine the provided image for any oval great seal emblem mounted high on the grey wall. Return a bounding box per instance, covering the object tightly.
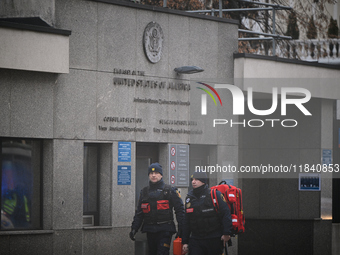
[143,21,164,64]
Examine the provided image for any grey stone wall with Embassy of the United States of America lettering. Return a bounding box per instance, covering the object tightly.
[0,0,237,254]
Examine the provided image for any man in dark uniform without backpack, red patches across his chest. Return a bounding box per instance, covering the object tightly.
[130,163,184,255]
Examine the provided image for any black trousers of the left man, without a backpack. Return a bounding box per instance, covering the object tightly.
[146,232,172,255]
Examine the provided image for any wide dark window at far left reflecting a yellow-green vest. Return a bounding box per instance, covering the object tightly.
[0,137,42,230]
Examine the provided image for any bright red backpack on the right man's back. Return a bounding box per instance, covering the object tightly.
[210,181,245,235]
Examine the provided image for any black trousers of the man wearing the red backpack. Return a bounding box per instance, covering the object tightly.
[189,237,224,255]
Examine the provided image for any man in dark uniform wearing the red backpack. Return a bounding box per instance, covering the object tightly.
[182,172,232,255]
